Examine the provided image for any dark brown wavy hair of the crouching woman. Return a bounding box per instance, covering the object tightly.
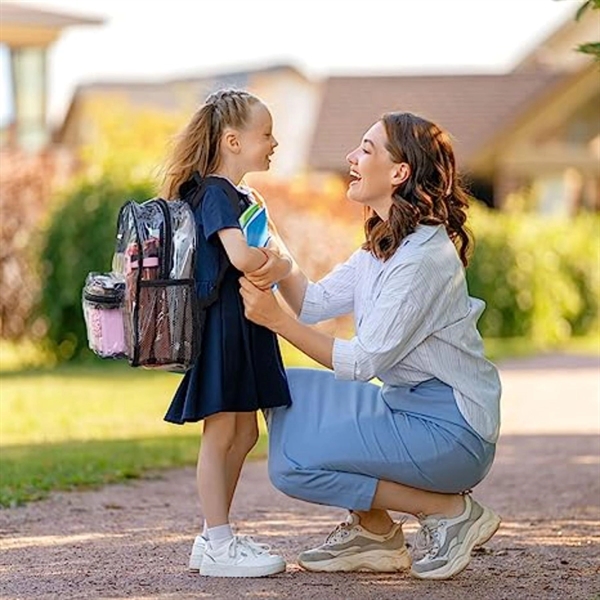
[363,112,471,266]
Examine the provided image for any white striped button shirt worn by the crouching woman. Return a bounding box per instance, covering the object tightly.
[300,225,501,443]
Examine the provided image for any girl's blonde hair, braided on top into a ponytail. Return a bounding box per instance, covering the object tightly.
[160,89,261,200]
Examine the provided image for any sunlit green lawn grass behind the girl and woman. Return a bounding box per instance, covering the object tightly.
[0,338,600,507]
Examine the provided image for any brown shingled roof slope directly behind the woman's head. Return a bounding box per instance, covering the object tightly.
[309,73,560,171]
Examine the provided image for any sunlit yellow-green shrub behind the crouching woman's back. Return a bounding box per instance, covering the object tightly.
[467,205,600,347]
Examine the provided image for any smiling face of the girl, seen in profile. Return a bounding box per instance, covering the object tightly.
[238,103,279,173]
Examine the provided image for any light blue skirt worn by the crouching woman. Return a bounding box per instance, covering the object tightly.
[266,368,495,510]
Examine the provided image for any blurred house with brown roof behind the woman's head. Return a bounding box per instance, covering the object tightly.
[309,10,600,214]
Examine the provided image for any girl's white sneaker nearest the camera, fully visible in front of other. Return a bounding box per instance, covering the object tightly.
[200,536,285,577]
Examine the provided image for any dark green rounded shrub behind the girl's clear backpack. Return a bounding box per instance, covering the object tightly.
[38,177,153,361]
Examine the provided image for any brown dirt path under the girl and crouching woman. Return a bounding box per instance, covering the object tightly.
[0,359,600,600]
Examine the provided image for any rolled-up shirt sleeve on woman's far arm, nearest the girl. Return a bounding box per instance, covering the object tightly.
[299,250,362,325]
